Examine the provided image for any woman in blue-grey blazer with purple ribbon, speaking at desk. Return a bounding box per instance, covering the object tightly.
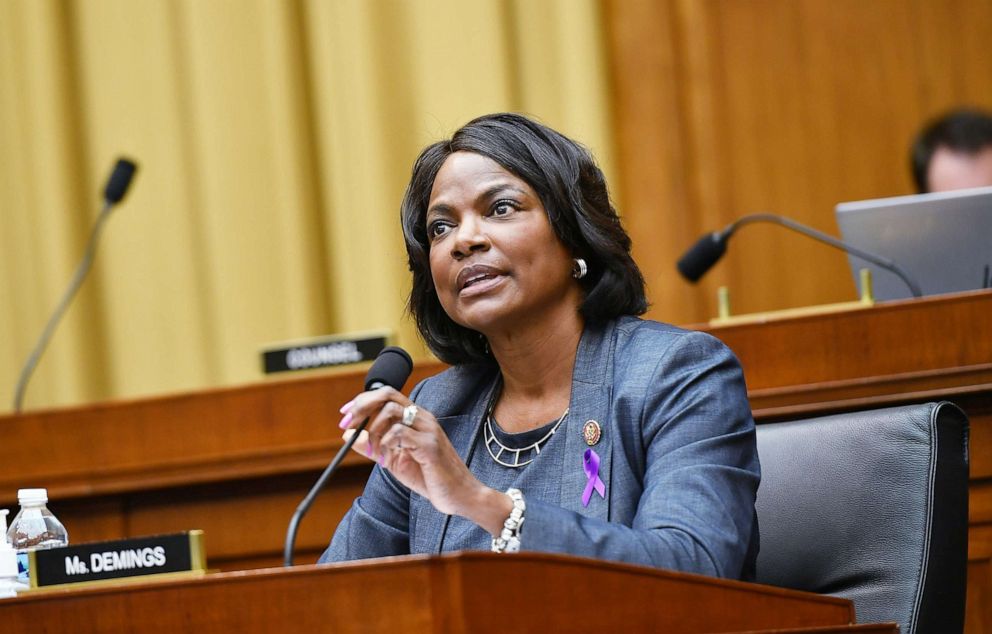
[321,114,760,579]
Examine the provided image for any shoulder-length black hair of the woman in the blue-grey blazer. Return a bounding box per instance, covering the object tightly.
[400,113,647,364]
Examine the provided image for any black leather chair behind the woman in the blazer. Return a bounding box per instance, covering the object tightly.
[757,403,968,634]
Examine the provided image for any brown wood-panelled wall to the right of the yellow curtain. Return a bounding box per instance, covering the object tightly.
[604,0,992,323]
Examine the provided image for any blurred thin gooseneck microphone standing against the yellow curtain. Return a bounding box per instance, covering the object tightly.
[14,158,138,414]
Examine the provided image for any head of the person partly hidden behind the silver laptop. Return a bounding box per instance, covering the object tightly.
[910,109,992,194]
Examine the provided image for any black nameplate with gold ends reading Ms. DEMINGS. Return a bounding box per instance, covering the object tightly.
[27,530,207,588]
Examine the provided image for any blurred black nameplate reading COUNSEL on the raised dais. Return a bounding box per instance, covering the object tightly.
[262,333,388,374]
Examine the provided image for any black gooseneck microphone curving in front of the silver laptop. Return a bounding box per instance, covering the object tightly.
[675,214,923,297]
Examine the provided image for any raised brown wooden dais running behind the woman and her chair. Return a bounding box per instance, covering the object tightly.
[0,291,992,632]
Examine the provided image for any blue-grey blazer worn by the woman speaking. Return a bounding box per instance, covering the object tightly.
[321,317,760,579]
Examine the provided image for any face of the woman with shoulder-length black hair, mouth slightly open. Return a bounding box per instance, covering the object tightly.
[426,152,582,338]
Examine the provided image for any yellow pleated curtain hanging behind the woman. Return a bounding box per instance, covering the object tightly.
[0,0,612,412]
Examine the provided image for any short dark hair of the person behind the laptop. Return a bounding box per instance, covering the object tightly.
[910,109,992,194]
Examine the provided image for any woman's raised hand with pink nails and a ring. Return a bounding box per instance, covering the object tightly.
[340,387,513,535]
